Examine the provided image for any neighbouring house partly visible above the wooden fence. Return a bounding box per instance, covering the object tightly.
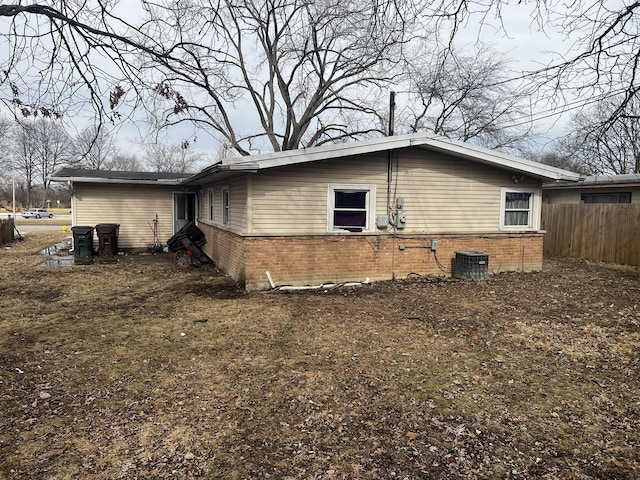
[542,173,640,204]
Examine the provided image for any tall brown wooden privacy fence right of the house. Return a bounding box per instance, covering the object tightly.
[542,203,640,266]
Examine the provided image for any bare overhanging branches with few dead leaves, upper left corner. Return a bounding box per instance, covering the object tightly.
[0,0,156,123]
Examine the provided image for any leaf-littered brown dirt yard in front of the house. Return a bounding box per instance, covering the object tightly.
[0,233,640,480]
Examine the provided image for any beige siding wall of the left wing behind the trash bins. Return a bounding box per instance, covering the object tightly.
[73,184,175,249]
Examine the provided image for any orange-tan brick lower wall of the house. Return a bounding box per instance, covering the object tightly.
[200,225,544,290]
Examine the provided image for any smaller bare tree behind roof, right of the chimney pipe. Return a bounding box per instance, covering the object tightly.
[399,48,532,150]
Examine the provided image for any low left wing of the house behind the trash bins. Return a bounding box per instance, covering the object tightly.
[50,168,191,249]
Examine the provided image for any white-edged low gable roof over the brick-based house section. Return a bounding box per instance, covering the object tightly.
[185,133,581,184]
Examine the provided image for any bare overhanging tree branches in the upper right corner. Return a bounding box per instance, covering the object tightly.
[424,0,640,135]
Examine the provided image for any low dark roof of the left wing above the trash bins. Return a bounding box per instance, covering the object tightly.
[49,167,190,185]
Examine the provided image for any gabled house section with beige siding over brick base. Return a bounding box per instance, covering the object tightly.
[180,134,579,290]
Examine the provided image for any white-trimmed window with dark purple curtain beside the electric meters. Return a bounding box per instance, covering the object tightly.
[327,184,376,232]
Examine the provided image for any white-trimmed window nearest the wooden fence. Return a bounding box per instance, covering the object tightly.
[500,188,539,230]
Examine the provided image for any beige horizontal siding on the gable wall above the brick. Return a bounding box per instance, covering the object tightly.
[249,149,539,235]
